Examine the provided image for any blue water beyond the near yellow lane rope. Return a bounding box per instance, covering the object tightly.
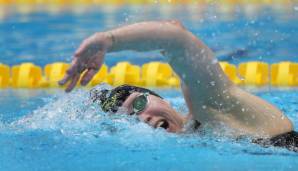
[0,5,298,66]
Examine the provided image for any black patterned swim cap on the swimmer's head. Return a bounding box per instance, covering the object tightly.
[90,85,162,113]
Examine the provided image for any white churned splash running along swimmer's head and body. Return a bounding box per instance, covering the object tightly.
[0,87,297,154]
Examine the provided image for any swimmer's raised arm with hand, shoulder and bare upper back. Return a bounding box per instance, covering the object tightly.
[62,21,292,138]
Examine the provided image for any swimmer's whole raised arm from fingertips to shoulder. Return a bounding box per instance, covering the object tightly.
[60,21,231,104]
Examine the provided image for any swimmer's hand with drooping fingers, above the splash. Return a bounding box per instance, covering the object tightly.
[59,32,112,92]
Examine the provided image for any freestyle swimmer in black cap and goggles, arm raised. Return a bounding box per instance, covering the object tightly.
[59,21,298,151]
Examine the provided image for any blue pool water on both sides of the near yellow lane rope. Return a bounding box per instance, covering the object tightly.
[0,6,298,170]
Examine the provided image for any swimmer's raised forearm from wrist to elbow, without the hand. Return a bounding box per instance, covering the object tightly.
[106,21,186,52]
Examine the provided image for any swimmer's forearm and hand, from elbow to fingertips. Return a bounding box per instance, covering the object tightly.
[59,21,191,92]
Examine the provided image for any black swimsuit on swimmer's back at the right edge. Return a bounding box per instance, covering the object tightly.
[252,131,298,152]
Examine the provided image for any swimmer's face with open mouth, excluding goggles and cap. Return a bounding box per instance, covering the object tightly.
[122,92,185,133]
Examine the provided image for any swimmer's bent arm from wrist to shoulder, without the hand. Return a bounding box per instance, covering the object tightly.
[107,21,232,99]
